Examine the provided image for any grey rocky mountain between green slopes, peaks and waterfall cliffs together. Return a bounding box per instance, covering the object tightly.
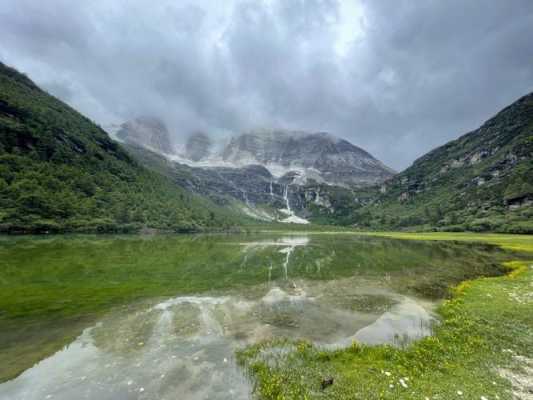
[117,119,394,223]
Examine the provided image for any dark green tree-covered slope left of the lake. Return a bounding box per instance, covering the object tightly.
[0,63,238,232]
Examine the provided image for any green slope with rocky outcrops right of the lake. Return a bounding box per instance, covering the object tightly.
[351,93,533,232]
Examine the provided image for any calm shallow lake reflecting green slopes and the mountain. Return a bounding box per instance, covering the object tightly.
[0,234,511,400]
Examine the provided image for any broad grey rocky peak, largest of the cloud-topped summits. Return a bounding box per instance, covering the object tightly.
[221,130,394,186]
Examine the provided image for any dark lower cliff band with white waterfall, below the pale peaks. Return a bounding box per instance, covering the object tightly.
[127,145,369,223]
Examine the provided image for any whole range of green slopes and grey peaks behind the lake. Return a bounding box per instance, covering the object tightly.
[0,63,533,233]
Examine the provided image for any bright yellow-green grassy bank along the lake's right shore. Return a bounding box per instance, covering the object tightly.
[239,232,533,400]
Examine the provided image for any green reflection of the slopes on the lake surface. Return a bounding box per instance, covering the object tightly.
[0,234,510,381]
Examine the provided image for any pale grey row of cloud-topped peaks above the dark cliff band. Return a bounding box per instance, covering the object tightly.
[117,120,396,186]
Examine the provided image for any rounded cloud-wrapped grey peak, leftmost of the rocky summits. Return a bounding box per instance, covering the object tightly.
[116,117,175,154]
